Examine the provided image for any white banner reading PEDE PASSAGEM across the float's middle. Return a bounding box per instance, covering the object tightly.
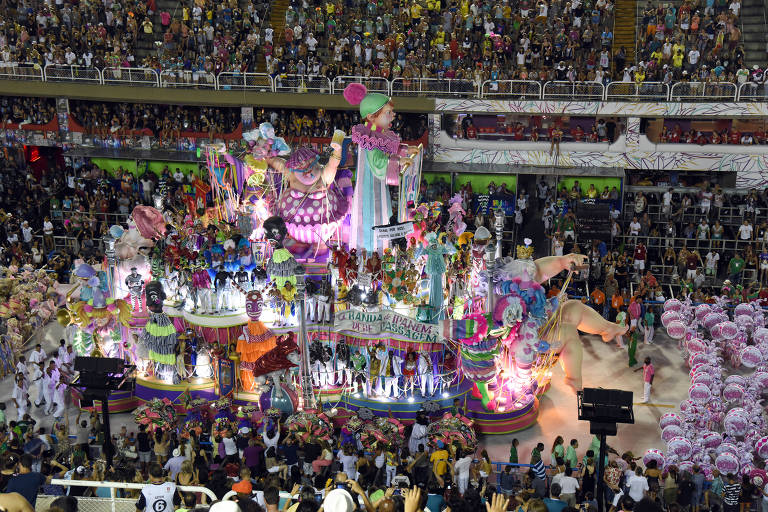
[333,309,444,343]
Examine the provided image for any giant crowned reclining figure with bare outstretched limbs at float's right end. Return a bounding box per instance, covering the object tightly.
[452,250,627,410]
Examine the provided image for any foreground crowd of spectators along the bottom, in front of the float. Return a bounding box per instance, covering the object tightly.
[0,400,736,512]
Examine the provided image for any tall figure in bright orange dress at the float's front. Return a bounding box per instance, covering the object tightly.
[235,290,277,391]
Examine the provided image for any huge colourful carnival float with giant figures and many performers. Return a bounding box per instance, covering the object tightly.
[58,84,624,436]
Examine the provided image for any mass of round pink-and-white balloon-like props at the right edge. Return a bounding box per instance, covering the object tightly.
[656,299,768,482]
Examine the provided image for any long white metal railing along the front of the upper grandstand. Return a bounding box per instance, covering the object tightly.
[0,62,768,102]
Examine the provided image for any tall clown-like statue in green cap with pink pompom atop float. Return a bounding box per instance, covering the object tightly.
[344,83,407,252]
